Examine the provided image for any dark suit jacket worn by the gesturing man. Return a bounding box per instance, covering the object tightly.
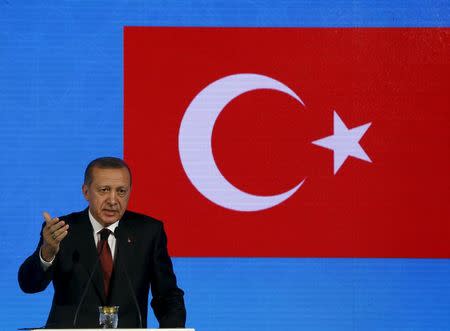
[18,209,186,328]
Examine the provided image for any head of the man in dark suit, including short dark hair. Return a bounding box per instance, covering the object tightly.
[82,157,131,226]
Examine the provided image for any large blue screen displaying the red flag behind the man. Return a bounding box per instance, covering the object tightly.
[0,1,450,331]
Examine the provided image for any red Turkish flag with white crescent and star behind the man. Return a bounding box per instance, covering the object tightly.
[124,27,450,258]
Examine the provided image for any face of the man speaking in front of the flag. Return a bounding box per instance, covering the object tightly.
[82,167,131,227]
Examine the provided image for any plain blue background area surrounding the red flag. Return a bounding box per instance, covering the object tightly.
[0,0,450,331]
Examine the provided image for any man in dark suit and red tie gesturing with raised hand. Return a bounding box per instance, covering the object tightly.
[18,157,186,328]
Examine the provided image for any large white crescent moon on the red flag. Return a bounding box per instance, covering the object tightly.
[178,74,305,211]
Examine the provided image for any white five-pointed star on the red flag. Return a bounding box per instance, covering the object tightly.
[312,111,372,174]
